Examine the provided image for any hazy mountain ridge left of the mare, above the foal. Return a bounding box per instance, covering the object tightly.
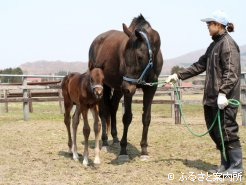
[20,60,88,75]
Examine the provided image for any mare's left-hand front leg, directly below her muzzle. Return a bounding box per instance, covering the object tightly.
[118,96,132,161]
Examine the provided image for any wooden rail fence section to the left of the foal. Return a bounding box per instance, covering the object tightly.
[0,74,63,121]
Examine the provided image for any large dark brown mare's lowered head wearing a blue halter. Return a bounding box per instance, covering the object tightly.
[122,15,160,95]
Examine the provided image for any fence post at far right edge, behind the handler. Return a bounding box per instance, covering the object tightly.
[241,73,246,126]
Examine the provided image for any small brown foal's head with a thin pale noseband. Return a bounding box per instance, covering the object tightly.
[90,68,104,99]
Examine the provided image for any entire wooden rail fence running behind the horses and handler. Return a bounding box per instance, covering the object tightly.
[0,73,246,126]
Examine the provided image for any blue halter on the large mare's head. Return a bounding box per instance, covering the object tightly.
[123,31,153,85]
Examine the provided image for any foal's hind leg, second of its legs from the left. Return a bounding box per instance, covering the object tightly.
[72,106,80,161]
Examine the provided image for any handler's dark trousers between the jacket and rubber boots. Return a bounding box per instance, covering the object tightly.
[204,105,241,150]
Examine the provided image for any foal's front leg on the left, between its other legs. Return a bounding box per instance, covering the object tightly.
[81,107,91,166]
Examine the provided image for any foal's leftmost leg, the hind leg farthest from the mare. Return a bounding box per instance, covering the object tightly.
[64,100,73,153]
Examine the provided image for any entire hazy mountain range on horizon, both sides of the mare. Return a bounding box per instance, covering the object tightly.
[20,45,246,74]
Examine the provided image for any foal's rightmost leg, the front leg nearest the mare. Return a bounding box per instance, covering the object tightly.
[91,105,101,164]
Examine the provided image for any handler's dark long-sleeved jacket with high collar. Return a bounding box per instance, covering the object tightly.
[177,32,241,106]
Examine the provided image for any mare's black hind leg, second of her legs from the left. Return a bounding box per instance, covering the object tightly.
[110,90,123,144]
